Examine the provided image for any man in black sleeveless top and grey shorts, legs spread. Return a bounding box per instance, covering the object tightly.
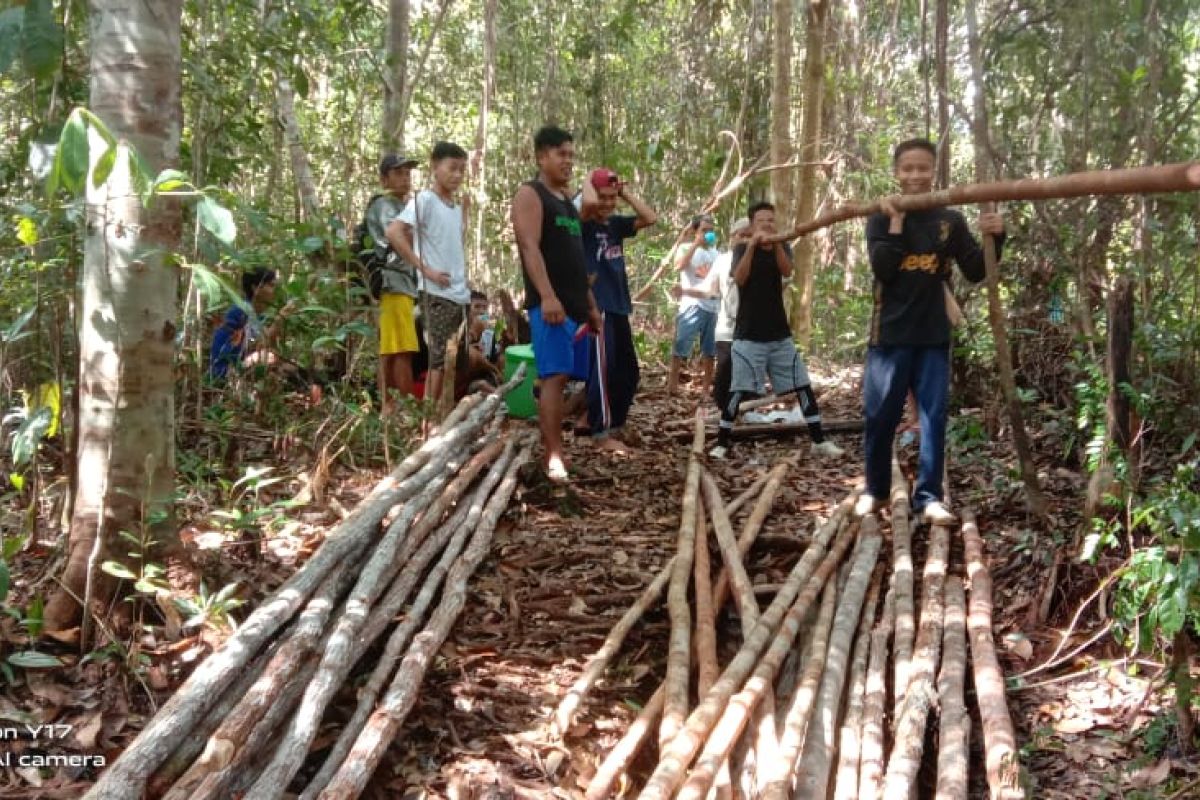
[709,203,844,458]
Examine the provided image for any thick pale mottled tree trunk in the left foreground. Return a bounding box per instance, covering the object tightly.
[46,0,182,644]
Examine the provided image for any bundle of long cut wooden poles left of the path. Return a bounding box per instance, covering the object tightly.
[86,374,532,800]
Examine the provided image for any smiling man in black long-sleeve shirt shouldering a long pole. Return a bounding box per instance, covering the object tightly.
[856,139,1004,524]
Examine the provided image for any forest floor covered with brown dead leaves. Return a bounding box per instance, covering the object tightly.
[0,365,1200,800]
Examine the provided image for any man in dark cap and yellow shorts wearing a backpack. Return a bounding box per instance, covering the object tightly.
[366,152,420,414]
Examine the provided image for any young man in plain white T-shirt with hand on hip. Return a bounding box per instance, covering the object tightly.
[388,142,470,401]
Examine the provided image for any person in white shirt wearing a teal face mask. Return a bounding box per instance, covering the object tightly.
[667,215,716,395]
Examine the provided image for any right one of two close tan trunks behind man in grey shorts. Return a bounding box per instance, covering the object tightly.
[792,0,836,348]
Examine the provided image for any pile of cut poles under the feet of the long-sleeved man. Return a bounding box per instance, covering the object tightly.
[552,416,1024,800]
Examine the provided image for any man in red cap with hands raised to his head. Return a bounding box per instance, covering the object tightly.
[578,167,658,452]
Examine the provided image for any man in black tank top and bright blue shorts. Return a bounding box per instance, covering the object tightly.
[511,126,600,480]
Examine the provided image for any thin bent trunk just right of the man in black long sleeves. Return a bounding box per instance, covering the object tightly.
[966,0,1048,519]
